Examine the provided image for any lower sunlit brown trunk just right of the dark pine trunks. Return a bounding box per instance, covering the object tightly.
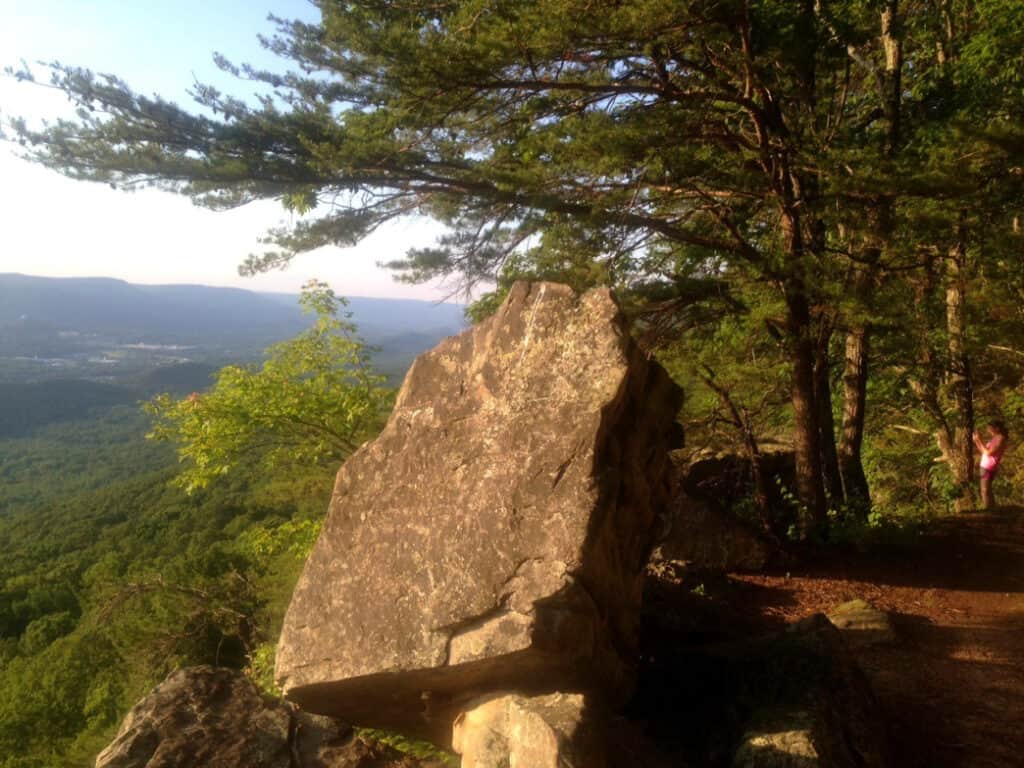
[839,325,871,515]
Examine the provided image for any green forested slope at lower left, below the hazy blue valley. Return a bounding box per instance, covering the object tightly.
[0,406,332,768]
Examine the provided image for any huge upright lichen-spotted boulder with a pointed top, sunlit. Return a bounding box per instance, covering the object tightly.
[276,284,680,743]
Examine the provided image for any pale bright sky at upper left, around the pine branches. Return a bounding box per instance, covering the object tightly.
[0,0,451,300]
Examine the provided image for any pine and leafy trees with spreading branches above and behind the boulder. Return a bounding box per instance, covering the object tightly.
[8,0,1024,535]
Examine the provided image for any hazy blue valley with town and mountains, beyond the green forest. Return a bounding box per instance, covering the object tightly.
[0,274,465,405]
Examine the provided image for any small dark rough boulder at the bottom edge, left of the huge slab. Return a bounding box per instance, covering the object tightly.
[96,667,438,768]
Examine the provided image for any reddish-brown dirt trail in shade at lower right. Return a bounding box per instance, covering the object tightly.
[729,508,1024,768]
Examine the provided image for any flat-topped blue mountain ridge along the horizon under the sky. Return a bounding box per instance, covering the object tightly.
[0,273,465,344]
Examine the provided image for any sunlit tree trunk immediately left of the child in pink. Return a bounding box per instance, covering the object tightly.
[946,231,976,511]
